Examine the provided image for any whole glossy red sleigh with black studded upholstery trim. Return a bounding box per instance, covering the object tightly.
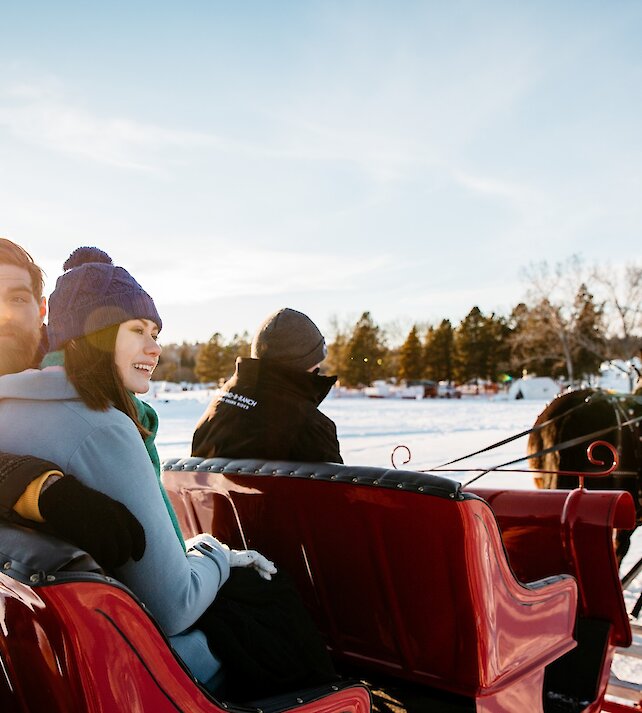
[0,458,634,713]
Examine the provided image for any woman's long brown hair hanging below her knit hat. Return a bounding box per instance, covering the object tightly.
[64,324,150,439]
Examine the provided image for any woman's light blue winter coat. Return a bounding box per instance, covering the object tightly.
[0,367,229,680]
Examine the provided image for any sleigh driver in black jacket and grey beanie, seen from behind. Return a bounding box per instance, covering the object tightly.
[192,307,343,463]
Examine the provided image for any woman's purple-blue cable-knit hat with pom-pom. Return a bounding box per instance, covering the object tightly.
[47,247,163,351]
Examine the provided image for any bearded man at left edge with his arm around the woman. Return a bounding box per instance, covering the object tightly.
[0,238,145,569]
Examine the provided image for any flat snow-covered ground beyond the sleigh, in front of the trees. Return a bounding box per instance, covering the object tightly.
[154,391,642,682]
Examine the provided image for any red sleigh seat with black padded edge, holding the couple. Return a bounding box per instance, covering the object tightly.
[0,523,370,713]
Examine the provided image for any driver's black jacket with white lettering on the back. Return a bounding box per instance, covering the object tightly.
[192,359,343,463]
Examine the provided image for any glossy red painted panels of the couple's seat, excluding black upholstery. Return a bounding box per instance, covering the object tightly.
[0,574,370,713]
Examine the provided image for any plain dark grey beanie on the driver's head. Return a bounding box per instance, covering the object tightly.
[252,307,327,371]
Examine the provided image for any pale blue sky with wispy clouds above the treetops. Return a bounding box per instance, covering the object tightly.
[0,0,642,341]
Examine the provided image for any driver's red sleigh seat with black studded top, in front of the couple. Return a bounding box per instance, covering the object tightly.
[163,458,577,713]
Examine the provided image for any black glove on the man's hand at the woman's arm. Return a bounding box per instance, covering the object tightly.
[38,475,145,570]
